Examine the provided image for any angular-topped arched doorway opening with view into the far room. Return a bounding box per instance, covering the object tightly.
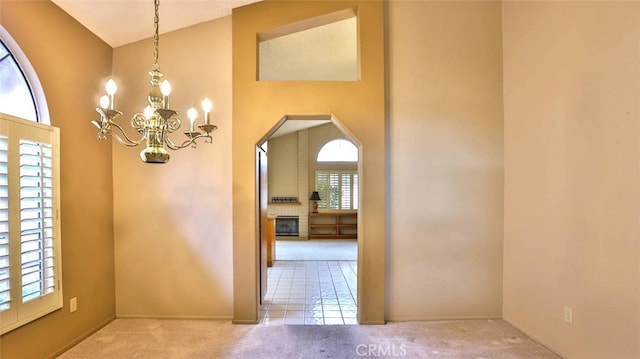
[257,115,361,325]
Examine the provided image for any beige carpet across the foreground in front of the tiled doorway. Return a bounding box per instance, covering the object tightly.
[60,319,559,359]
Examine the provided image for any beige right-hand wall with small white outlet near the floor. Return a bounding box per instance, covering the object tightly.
[503,2,640,359]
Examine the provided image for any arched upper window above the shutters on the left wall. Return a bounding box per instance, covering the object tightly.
[0,26,50,124]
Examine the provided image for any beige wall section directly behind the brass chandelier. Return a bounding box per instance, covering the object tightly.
[113,17,233,318]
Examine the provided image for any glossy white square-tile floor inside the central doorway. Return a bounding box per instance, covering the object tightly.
[259,261,358,325]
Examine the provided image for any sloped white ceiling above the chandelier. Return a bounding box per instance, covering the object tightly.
[52,0,260,47]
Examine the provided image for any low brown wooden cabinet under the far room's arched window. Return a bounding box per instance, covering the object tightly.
[309,212,358,239]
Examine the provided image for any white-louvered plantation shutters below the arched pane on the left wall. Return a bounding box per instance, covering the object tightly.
[0,114,62,334]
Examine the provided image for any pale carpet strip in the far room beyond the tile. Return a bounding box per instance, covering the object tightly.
[276,239,358,261]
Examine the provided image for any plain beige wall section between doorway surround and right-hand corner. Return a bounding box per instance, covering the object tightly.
[387,1,503,320]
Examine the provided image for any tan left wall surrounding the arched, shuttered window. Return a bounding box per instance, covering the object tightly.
[0,0,115,359]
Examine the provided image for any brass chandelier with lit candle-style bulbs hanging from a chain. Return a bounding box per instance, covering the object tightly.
[91,0,218,163]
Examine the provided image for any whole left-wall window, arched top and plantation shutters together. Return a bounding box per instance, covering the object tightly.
[0,26,63,335]
